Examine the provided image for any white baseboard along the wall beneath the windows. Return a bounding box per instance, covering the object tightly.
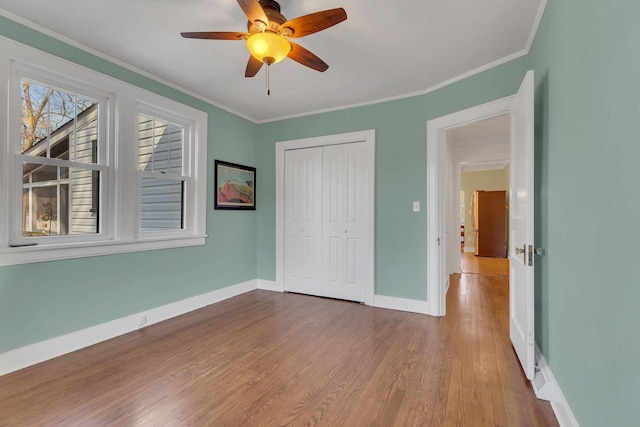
[0,280,258,376]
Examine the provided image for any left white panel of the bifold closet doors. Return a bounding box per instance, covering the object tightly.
[284,147,322,295]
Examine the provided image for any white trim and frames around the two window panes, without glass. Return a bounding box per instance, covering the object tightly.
[0,37,207,266]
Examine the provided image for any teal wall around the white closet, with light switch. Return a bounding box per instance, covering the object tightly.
[257,57,528,301]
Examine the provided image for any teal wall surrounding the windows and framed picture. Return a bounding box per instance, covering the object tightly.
[0,17,260,353]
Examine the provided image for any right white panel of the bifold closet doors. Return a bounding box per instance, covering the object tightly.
[322,142,367,302]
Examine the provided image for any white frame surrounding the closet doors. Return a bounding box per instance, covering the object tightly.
[273,129,376,305]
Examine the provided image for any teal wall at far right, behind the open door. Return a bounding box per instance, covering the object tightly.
[529,0,640,427]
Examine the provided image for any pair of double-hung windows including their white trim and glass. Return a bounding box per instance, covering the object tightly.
[0,40,207,265]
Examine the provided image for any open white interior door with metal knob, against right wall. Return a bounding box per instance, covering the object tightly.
[509,71,535,380]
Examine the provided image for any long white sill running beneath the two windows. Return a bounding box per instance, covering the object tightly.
[0,235,207,267]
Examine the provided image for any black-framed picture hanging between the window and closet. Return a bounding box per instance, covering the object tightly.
[214,160,256,210]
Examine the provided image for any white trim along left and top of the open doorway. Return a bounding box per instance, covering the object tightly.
[427,96,514,316]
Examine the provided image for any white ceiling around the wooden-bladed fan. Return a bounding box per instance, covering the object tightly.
[0,0,546,123]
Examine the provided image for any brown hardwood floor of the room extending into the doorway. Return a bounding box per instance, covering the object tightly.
[0,260,557,426]
